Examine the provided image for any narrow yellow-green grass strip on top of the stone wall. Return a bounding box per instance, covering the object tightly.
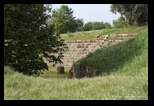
[61,26,148,40]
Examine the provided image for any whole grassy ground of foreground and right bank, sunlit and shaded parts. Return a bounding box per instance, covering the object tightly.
[4,26,148,100]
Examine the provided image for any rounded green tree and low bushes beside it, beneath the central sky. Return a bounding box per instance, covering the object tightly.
[49,5,111,34]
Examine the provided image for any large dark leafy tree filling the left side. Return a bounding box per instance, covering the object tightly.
[4,4,66,75]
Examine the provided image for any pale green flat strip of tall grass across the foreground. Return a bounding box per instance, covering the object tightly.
[4,68,148,100]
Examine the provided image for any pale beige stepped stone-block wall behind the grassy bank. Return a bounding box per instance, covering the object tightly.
[45,34,137,67]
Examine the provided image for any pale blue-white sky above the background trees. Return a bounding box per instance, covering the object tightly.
[52,4,120,25]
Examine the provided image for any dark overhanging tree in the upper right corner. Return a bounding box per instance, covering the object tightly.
[111,4,148,25]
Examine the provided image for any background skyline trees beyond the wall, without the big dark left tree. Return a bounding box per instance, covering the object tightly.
[50,4,148,33]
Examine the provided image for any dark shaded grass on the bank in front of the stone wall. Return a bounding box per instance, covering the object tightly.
[79,32,148,75]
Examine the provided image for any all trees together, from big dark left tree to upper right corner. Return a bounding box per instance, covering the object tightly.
[4,4,148,75]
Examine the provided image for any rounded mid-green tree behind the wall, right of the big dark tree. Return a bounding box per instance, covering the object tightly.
[51,5,77,34]
